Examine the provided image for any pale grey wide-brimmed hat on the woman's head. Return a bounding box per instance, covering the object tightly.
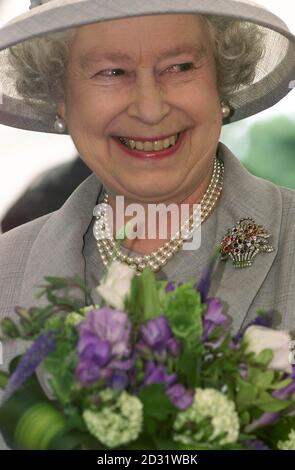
[0,0,295,133]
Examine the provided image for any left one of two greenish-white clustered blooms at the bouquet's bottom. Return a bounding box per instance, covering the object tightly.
[83,389,143,448]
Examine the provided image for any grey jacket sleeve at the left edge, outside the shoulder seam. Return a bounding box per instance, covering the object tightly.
[0,213,52,319]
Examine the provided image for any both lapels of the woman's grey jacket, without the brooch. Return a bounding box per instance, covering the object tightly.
[19,144,282,327]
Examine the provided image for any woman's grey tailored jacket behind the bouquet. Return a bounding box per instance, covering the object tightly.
[0,144,295,448]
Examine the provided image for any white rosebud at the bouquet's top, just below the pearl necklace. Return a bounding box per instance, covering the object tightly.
[96,260,135,310]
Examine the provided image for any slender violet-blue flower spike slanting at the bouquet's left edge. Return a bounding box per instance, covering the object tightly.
[4,331,56,399]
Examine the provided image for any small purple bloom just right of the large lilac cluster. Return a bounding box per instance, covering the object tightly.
[136,315,181,359]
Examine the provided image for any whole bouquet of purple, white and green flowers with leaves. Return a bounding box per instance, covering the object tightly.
[0,248,295,450]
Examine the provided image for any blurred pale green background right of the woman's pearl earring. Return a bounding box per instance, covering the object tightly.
[220,116,295,189]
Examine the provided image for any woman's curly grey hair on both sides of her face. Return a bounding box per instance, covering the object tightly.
[8,16,265,114]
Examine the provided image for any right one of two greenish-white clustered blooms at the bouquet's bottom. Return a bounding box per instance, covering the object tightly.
[173,388,240,446]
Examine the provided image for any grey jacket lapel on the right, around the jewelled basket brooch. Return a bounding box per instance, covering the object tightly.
[210,144,282,329]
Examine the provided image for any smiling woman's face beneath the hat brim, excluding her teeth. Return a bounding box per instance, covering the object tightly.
[59,14,222,202]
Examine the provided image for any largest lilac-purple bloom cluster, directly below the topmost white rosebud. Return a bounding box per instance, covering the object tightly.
[76,307,134,385]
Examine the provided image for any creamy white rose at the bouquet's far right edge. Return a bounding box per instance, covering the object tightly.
[244,325,292,374]
